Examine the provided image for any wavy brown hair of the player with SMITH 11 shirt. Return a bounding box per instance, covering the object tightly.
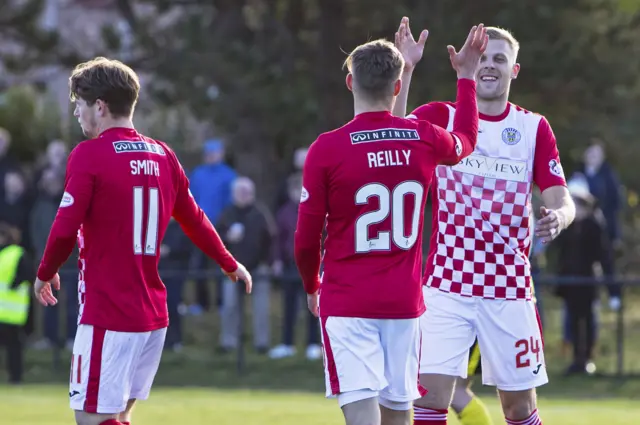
[69,57,140,117]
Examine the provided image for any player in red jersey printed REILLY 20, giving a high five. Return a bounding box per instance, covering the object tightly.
[295,26,487,425]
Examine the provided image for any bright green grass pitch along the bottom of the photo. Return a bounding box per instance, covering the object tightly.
[0,385,640,425]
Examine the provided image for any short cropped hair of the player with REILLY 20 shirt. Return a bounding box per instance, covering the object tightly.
[344,39,404,100]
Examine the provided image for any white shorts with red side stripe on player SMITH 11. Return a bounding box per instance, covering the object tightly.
[69,325,167,414]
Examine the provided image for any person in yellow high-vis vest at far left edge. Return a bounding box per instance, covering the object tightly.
[0,224,33,384]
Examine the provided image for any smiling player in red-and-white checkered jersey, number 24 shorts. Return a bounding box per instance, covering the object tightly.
[394,18,575,425]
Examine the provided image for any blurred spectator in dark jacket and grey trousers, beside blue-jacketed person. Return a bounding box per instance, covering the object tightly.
[218,177,275,353]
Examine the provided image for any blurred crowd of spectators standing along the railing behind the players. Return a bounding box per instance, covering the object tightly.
[0,129,622,380]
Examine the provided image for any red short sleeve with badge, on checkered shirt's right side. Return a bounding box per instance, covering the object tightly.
[533,117,567,192]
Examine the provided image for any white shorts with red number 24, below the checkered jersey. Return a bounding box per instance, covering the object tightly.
[420,286,549,391]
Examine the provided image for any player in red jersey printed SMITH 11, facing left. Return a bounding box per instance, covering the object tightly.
[35,58,251,425]
